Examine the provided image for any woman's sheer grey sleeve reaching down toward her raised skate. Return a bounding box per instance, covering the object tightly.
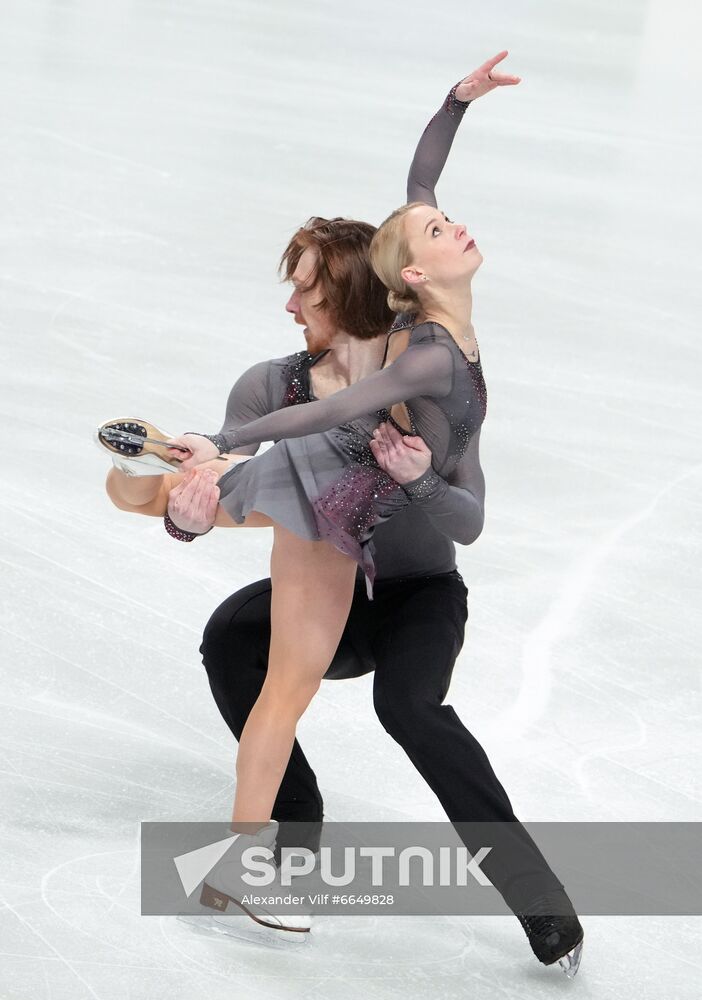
[216,342,453,452]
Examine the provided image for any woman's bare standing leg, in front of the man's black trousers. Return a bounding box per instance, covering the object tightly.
[232,524,356,832]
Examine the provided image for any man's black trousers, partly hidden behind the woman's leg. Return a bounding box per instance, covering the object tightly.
[200,570,562,909]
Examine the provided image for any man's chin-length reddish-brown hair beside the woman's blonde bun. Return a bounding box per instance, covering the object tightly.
[280,216,394,340]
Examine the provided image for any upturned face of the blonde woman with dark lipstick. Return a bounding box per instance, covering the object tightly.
[403,205,483,287]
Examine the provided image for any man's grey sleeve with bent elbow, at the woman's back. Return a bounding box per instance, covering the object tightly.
[402,428,485,545]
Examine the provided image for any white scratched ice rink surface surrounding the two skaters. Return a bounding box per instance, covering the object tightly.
[0,0,702,1000]
